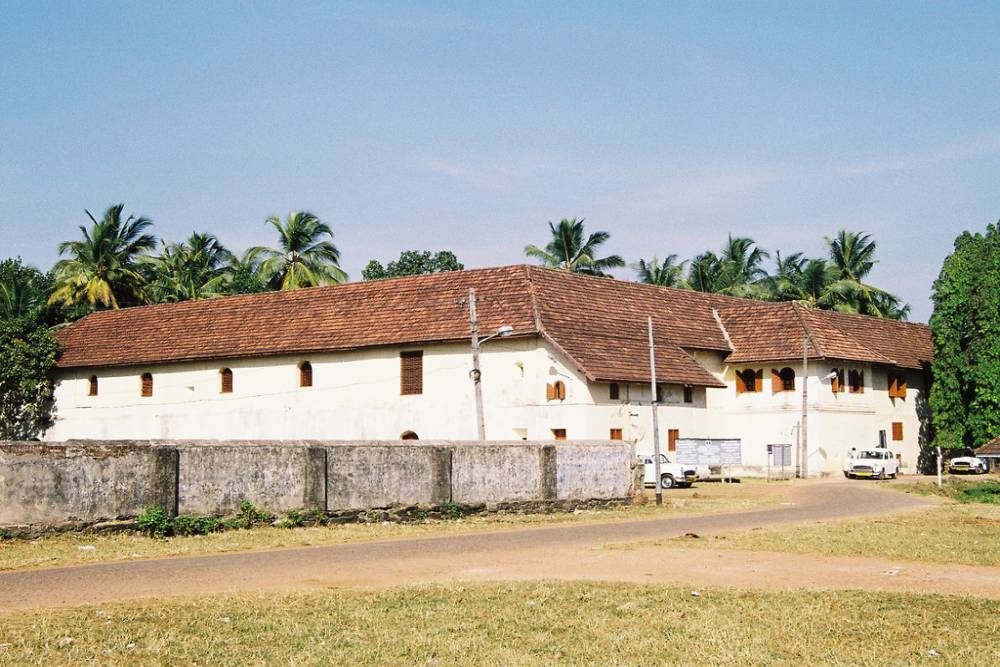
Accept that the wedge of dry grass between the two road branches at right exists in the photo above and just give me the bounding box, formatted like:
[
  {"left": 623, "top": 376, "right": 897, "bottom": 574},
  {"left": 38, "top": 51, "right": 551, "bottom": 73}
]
[{"left": 640, "top": 504, "right": 1000, "bottom": 567}]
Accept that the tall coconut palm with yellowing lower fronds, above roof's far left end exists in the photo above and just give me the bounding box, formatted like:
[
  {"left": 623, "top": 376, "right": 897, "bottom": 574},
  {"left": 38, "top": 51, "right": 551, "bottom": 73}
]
[{"left": 49, "top": 204, "right": 156, "bottom": 309}]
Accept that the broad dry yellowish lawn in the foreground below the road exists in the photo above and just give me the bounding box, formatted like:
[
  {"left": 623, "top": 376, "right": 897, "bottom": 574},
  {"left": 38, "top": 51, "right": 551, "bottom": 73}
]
[{"left": 0, "top": 582, "right": 1000, "bottom": 665}]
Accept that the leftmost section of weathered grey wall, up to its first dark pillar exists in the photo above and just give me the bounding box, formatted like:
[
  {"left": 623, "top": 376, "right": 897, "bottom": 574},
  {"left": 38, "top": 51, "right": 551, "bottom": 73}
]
[{"left": 0, "top": 442, "right": 177, "bottom": 525}]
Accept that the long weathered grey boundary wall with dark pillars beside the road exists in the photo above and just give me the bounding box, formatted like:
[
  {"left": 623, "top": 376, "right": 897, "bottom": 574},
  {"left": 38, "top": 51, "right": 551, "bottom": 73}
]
[{"left": 0, "top": 440, "right": 632, "bottom": 526}]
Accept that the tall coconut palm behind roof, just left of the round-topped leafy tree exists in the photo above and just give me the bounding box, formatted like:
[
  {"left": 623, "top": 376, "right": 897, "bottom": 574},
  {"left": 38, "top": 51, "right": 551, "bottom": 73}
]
[{"left": 246, "top": 211, "right": 347, "bottom": 290}]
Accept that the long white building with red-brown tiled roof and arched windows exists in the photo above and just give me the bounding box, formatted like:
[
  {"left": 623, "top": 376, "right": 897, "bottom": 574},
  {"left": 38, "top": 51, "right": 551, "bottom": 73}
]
[{"left": 45, "top": 266, "right": 931, "bottom": 475}]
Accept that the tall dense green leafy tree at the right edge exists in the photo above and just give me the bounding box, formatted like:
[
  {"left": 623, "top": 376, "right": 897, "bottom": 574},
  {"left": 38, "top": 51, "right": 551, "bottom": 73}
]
[{"left": 930, "top": 223, "right": 1000, "bottom": 449}]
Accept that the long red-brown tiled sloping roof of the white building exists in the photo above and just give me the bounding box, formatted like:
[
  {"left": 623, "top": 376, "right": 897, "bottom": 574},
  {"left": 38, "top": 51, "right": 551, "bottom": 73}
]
[{"left": 58, "top": 266, "right": 930, "bottom": 386}]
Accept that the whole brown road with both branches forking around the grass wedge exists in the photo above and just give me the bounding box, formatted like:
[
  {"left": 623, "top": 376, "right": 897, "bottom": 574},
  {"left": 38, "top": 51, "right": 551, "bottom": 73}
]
[{"left": 0, "top": 482, "right": 1000, "bottom": 611}]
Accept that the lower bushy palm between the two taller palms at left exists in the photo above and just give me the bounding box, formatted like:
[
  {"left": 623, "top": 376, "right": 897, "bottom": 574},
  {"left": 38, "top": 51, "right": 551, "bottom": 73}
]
[{"left": 150, "top": 232, "right": 234, "bottom": 302}]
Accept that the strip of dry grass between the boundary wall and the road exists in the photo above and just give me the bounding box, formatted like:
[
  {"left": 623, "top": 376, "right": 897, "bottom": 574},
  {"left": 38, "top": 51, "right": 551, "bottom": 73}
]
[{"left": 0, "top": 483, "right": 790, "bottom": 570}]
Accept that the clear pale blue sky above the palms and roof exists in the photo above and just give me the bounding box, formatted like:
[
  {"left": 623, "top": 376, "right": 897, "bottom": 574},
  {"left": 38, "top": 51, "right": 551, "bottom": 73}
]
[{"left": 0, "top": 0, "right": 1000, "bottom": 321}]
